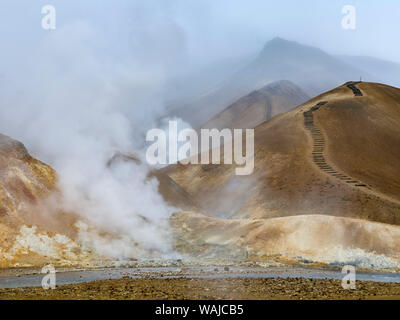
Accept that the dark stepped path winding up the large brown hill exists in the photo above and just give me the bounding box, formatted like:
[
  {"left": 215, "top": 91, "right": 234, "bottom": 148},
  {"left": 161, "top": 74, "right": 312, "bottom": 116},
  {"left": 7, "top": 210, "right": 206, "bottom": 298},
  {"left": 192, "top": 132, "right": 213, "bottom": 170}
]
[{"left": 303, "top": 82, "right": 368, "bottom": 188}]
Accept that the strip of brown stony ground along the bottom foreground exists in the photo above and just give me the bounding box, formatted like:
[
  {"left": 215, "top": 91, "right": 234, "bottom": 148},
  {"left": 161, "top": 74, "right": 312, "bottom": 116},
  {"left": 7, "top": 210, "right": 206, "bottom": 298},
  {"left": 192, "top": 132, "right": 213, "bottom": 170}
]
[{"left": 0, "top": 278, "right": 400, "bottom": 300}]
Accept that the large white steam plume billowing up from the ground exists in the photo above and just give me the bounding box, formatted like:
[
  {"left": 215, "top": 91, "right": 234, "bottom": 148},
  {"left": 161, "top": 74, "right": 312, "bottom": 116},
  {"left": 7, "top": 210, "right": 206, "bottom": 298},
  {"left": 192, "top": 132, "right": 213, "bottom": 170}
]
[{"left": 0, "top": 9, "right": 187, "bottom": 258}]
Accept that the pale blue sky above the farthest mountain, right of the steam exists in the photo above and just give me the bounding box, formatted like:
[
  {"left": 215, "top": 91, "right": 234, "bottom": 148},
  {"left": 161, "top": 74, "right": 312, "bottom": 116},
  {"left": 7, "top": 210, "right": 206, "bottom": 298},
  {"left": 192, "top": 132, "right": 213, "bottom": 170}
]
[{"left": 168, "top": 0, "right": 400, "bottom": 62}]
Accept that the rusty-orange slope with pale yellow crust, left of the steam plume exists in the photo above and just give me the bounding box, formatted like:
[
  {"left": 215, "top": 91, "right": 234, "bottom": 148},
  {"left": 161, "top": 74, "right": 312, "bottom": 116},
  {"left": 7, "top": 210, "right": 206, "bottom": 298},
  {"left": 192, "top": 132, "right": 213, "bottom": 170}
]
[{"left": 0, "top": 134, "right": 86, "bottom": 268}]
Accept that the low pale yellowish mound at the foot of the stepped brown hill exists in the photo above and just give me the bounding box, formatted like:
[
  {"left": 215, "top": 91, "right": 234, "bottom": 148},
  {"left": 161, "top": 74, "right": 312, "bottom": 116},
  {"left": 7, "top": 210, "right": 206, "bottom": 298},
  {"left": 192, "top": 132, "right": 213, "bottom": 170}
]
[{"left": 172, "top": 212, "right": 400, "bottom": 270}]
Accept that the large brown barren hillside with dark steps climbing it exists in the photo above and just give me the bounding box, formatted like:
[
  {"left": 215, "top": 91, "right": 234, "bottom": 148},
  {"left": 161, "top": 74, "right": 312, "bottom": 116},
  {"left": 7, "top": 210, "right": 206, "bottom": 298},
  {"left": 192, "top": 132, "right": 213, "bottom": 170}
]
[{"left": 162, "top": 83, "right": 400, "bottom": 224}]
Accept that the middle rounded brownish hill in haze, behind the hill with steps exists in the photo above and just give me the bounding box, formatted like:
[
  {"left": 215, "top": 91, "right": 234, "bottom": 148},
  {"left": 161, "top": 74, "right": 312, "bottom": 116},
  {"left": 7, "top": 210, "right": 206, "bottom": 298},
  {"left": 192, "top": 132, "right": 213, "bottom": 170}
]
[{"left": 201, "top": 80, "right": 310, "bottom": 129}]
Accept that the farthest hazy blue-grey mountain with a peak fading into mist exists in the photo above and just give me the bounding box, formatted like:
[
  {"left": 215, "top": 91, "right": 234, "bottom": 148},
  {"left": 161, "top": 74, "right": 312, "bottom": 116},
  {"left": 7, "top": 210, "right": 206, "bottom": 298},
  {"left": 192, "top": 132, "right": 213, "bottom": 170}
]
[{"left": 171, "top": 38, "right": 371, "bottom": 128}]
